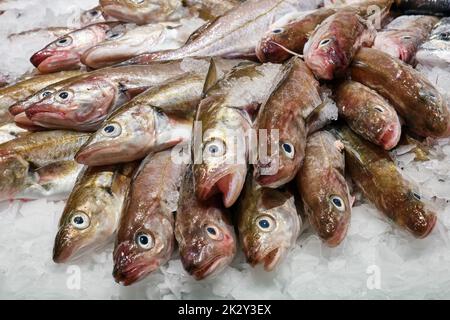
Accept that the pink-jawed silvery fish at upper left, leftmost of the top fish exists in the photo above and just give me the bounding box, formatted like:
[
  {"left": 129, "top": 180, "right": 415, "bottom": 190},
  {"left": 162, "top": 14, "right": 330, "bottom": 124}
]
[{"left": 30, "top": 22, "right": 125, "bottom": 73}]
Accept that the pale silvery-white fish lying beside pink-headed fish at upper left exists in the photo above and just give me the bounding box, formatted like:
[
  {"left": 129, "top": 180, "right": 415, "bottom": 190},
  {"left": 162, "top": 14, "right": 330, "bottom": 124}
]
[{"left": 81, "top": 19, "right": 201, "bottom": 69}]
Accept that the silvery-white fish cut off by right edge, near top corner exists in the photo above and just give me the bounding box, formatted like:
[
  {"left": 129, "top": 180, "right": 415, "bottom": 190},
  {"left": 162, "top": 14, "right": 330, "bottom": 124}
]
[{"left": 416, "top": 18, "right": 450, "bottom": 68}]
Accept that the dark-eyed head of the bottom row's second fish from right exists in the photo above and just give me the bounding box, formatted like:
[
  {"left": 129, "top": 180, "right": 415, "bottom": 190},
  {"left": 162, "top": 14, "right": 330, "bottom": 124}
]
[{"left": 305, "top": 168, "right": 352, "bottom": 247}]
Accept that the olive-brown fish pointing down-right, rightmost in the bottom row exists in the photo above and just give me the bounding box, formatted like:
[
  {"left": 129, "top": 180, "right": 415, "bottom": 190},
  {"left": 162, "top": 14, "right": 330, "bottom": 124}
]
[{"left": 336, "top": 127, "right": 436, "bottom": 238}]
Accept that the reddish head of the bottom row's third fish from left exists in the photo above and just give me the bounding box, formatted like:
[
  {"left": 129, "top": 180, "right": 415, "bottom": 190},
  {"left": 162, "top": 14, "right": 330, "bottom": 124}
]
[{"left": 177, "top": 205, "right": 236, "bottom": 280}]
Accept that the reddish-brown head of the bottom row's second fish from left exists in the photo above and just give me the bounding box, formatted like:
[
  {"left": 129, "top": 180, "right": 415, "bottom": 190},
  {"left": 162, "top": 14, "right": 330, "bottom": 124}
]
[{"left": 113, "top": 214, "right": 175, "bottom": 286}]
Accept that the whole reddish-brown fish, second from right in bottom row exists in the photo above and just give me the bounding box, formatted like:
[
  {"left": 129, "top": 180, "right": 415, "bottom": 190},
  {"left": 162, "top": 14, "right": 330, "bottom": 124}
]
[{"left": 297, "top": 131, "right": 352, "bottom": 247}]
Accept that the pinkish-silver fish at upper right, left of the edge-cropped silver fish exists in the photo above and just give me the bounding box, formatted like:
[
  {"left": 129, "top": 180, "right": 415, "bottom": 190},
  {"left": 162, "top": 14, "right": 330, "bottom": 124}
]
[{"left": 373, "top": 15, "right": 439, "bottom": 64}]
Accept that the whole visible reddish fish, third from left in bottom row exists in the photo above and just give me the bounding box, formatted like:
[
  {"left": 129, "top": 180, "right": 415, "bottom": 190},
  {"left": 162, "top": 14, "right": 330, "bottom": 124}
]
[{"left": 175, "top": 167, "right": 236, "bottom": 280}]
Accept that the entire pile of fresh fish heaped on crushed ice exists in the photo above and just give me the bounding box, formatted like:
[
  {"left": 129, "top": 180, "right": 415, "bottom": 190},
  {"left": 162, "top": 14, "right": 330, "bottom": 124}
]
[{"left": 0, "top": 0, "right": 450, "bottom": 285}]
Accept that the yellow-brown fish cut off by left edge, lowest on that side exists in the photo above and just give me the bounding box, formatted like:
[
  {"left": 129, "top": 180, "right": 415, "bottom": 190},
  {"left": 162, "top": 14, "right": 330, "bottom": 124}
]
[{"left": 0, "top": 131, "right": 89, "bottom": 200}]
